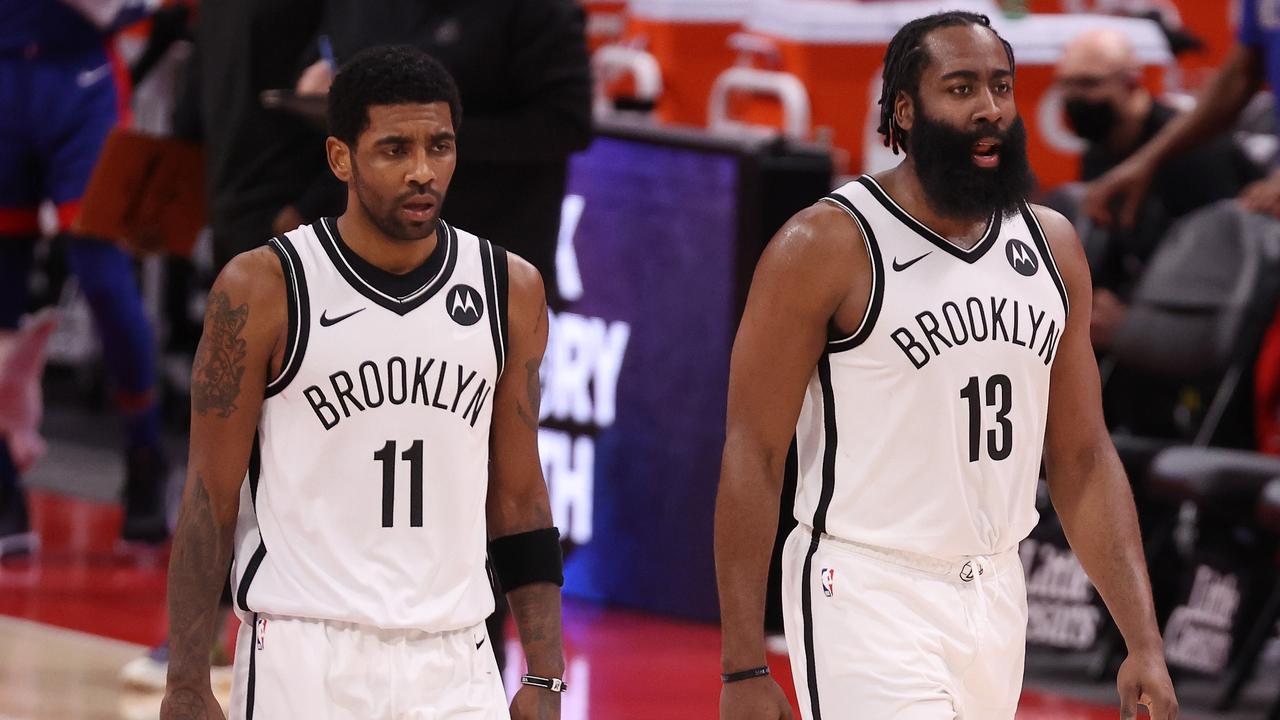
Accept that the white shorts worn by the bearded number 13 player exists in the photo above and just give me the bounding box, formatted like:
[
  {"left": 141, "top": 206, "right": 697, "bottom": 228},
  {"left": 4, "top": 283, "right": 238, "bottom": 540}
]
[{"left": 782, "top": 524, "right": 1027, "bottom": 720}]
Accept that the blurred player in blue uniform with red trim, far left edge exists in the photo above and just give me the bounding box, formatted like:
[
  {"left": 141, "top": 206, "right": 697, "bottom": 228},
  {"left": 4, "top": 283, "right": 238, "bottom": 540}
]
[{"left": 0, "top": 0, "right": 168, "bottom": 553}]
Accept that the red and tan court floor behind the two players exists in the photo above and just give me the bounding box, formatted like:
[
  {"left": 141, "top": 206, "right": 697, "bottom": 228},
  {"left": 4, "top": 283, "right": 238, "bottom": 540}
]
[{"left": 0, "top": 492, "right": 1119, "bottom": 720}]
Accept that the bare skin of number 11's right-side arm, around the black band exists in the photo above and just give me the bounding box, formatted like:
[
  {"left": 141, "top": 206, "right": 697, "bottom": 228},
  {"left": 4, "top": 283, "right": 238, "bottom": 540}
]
[{"left": 488, "top": 255, "right": 564, "bottom": 720}]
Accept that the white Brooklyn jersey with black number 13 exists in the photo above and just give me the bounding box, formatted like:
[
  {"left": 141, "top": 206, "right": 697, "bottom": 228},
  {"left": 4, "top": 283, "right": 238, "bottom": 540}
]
[{"left": 795, "top": 176, "right": 1068, "bottom": 557}]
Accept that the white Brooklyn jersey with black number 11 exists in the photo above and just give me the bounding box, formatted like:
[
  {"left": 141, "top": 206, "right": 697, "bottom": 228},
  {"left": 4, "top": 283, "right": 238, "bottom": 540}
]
[{"left": 233, "top": 219, "right": 507, "bottom": 632}]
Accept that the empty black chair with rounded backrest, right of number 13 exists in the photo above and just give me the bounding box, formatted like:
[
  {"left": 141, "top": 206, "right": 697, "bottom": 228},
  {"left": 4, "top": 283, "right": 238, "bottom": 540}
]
[{"left": 1091, "top": 200, "right": 1280, "bottom": 679}]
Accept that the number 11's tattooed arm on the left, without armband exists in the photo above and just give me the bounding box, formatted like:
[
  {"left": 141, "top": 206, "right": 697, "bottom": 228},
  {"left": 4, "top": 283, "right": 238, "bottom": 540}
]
[{"left": 160, "top": 249, "right": 287, "bottom": 720}]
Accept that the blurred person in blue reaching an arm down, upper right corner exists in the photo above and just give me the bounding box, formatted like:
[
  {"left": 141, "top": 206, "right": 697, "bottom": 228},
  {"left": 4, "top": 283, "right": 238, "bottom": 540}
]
[{"left": 1084, "top": 0, "right": 1280, "bottom": 228}]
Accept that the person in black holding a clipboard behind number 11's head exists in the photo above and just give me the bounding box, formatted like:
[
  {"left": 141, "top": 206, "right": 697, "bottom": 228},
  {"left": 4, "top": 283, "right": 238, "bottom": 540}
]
[{"left": 298, "top": 0, "right": 591, "bottom": 304}]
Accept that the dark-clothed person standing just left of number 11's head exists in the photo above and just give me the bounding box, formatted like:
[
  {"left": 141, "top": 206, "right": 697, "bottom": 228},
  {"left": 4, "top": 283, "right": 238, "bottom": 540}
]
[{"left": 179, "top": 0, "right": 346, "bottom": 269}]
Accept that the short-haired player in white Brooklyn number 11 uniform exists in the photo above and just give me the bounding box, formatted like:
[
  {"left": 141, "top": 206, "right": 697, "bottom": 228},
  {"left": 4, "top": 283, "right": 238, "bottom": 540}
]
[{"left": 160, "top": 47, "right": 564, "bottom": 720}]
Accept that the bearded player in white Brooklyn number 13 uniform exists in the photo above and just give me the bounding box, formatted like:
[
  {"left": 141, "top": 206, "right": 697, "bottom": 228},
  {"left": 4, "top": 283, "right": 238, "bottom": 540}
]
[{"left": 716, "top": 12, "right": 1178, "bottom": 720}]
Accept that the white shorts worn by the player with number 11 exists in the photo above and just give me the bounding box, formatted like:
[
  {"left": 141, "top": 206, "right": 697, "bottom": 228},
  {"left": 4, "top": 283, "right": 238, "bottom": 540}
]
[{"left": 230, "top": 614, "right": 509, "bottom": 720}]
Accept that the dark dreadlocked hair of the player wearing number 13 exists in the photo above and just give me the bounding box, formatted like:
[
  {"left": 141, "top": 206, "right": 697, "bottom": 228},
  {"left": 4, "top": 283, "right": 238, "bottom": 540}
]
[{"left": 877, "top": 10, "right": 1014, "bottom": 155}]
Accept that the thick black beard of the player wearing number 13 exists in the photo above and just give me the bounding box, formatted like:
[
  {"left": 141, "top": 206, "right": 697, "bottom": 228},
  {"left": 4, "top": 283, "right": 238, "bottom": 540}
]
[{"left": 908, "top": 102, "right": 1036, "bottom": 220}]
